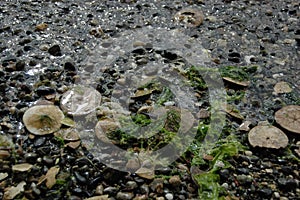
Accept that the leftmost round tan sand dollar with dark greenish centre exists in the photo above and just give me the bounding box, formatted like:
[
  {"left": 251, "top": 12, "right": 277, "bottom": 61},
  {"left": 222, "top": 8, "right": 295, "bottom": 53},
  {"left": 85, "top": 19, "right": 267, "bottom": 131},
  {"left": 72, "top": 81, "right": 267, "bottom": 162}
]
[{"left": 23, "top": 105, "right": 65, "bottom": 135}]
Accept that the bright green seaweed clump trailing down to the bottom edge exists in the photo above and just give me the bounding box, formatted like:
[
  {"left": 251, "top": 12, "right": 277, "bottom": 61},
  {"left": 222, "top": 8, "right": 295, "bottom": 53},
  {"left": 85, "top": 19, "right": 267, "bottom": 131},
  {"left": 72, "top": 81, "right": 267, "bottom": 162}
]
[{"left": 189, "top": 119, "right": 245, "bottom": 200}]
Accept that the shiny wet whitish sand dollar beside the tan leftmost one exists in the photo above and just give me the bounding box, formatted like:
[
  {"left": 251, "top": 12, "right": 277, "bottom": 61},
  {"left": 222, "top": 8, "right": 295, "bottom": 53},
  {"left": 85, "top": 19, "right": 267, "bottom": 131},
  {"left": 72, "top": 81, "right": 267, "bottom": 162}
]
[{"left": 60, "top": 85, "right": 101, "bottom": 116}]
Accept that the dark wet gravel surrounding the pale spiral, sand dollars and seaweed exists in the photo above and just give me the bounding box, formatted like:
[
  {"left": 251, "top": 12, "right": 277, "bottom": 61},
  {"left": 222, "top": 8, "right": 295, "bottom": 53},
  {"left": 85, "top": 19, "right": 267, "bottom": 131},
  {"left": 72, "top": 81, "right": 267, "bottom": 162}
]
[{"left": 0, "top": 0, "right": 300, "bottom": 200}]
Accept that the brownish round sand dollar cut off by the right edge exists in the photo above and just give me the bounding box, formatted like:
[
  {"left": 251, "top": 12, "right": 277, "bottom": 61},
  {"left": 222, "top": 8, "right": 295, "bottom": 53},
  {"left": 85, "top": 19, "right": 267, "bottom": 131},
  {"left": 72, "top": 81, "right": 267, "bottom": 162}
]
[{"left": 275, "top": 105, "right": 300, "bottom": 133}]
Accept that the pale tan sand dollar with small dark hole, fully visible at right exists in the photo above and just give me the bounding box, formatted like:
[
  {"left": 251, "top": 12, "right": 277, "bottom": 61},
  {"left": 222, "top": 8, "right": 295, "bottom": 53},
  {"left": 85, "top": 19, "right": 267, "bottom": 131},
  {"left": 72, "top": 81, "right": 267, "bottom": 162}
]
[{"left": 248, "top": 125, "right": 289, "bottom": 149}]
